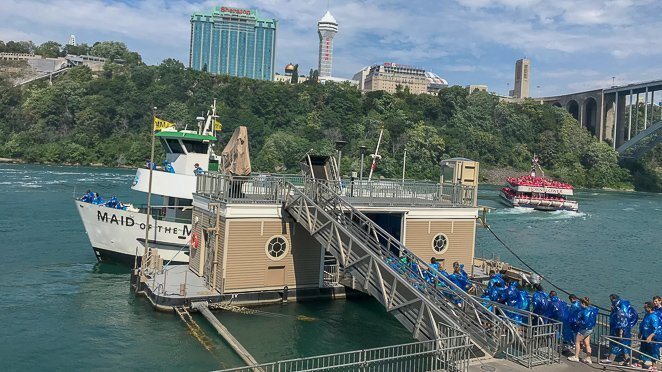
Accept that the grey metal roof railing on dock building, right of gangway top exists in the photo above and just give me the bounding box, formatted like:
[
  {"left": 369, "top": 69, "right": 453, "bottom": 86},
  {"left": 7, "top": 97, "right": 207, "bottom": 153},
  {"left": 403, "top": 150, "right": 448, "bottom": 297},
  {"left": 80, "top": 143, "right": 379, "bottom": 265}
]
[{"left": 340, "top": 179, "right": 477, "bottom": 207}]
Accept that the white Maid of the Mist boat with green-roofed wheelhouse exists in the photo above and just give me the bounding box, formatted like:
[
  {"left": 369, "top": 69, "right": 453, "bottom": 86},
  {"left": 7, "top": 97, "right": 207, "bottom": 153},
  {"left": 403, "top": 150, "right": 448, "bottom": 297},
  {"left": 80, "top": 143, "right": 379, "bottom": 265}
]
[{"left": 75, "top": 105, "right": 218, "bottom": 265}]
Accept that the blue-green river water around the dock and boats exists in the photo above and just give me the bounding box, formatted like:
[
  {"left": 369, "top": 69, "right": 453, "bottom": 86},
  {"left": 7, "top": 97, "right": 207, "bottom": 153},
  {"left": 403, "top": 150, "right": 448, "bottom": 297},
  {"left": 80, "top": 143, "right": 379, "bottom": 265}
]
[{"left": 0, "top": 164, "right": 662, "bottom": 370}]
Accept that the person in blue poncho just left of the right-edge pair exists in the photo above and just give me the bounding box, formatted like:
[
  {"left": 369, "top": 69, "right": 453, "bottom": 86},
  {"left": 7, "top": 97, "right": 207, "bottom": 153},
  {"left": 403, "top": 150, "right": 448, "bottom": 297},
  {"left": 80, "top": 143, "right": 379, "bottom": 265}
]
[{"left": 601, "top": 294, "right": 639, "bottom": 364}]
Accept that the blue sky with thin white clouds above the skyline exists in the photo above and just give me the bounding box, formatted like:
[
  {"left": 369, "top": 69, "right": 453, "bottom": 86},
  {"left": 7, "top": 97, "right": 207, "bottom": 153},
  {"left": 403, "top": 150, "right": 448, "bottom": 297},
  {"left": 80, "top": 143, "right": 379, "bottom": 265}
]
[{"left": 0, "top": 0, "right": 662, "bottom": 96}]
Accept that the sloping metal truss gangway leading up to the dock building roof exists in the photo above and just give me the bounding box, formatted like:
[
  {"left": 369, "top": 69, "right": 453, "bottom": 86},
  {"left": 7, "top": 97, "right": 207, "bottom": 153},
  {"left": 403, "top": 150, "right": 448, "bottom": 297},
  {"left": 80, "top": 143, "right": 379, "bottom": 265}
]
[{"left": 284, "top": 181, "right": 521, "bottom": 355}]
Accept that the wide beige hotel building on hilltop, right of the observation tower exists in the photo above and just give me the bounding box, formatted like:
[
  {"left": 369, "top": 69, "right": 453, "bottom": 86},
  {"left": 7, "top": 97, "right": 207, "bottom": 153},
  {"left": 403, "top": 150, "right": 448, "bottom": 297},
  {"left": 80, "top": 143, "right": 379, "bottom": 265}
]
[{"left": 354, "top": 62, "right": 448, "bottom": 94}]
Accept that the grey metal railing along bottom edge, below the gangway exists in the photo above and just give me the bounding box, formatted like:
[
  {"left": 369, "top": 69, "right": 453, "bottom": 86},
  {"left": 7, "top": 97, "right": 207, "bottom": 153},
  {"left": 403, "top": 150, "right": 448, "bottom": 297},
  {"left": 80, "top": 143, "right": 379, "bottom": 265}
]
[{"left": 218, "top": 334, "right": 471, "bottom": 372}]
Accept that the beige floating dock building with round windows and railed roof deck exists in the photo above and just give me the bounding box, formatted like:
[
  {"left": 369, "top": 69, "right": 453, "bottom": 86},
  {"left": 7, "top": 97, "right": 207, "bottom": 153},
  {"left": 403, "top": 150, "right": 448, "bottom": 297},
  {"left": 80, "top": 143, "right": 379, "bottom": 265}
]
[{"left": 189, "top": 155, "right": 478, "bottom": 302}]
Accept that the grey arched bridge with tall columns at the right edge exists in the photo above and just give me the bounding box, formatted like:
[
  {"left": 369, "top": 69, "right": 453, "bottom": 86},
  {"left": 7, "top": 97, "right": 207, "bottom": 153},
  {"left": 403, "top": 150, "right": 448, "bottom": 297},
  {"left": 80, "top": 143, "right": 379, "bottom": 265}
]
[{"left": 540, "top": 80, "right": 662, "bottom": 156}]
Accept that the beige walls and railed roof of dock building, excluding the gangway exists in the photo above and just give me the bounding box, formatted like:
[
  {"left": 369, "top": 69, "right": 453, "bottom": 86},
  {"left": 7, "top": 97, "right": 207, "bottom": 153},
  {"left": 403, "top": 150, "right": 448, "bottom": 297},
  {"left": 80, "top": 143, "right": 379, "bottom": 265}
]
[{"left": 189, "top": 158, "right": 478, "bottom": 294}]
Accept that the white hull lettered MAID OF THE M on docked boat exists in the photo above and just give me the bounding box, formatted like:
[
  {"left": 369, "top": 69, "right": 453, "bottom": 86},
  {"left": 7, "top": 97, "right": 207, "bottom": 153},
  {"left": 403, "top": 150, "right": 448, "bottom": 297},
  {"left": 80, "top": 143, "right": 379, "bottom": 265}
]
[{"left": 75, "top": 200, "right": 191, "bottom": 265}]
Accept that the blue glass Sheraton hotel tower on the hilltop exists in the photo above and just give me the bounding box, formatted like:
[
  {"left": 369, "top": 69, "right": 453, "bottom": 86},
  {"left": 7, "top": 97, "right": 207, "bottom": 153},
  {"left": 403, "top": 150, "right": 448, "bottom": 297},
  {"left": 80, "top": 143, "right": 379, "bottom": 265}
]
[{"left": 189, "top": 6, "right": 277, "bottom": 80}]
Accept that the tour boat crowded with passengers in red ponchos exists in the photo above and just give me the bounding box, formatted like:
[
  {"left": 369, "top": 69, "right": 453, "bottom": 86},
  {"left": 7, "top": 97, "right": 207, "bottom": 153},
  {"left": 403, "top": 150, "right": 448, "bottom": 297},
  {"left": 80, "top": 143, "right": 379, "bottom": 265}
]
[{"left": 499, "top": 156, "right": 579, "bottom": 212}]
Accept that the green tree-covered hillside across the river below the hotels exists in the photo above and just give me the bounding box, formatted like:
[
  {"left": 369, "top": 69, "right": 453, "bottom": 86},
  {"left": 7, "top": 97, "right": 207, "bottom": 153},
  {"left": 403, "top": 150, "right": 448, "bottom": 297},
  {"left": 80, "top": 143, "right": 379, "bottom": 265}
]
[{"left": 0, "top": 40, "right": 660, "bottom": 188}]
